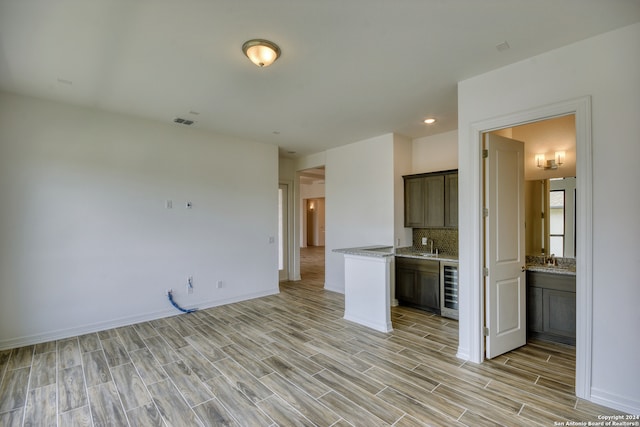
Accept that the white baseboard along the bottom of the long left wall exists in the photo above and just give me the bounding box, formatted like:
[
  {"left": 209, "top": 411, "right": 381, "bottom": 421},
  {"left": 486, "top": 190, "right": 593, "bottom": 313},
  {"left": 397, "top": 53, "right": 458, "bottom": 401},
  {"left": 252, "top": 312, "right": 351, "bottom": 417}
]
[{"left": 0, "top": 288, "right": 280, "bottom": 351}]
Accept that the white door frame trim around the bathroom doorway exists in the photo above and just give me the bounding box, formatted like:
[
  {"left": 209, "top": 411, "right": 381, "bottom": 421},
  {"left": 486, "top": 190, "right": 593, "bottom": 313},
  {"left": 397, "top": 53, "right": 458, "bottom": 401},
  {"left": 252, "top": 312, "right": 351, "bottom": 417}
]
[{"left": 468, "top": 96, "right": 593, "bottom": 400}]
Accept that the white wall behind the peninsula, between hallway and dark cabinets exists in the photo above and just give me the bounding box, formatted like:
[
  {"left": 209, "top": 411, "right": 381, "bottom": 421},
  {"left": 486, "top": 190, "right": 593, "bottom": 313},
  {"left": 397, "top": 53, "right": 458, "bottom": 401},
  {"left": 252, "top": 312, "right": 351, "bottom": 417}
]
[{"left": 325, "top": 134, "right": 395, "bottom": 293}]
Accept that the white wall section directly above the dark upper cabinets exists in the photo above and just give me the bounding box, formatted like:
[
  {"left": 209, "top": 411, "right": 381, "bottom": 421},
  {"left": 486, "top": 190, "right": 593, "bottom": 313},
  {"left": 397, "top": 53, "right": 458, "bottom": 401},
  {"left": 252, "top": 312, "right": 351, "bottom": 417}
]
[{"left": 411, "top": 130, "right": 458, "bottom": 173}]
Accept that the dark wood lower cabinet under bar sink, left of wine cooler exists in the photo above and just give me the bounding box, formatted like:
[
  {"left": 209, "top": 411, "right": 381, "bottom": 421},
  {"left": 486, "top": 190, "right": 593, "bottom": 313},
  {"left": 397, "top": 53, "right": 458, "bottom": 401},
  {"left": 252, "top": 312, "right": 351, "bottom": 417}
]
[{"left": 395, "top": 257, "right": 440, "bottom": 314}]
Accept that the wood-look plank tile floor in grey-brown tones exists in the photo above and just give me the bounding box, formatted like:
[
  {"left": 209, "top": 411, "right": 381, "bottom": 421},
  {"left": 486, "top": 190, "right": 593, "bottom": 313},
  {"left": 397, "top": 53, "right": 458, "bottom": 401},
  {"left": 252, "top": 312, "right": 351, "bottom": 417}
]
[{"left": 0, "top": 249, "right": 619, "bottom": 427}]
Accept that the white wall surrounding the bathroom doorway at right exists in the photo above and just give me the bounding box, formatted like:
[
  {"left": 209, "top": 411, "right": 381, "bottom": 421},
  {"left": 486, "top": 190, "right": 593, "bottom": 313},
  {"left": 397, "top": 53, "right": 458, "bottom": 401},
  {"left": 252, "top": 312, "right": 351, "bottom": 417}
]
[{"left": 458, "top": 24, "right": 640, "bottom": 414}]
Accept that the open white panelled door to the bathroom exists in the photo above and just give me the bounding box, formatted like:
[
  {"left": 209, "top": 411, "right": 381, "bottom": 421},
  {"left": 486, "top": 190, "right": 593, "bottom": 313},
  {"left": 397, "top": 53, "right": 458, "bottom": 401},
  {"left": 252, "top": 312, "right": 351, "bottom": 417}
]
[{"left": 484, "top": 134, "right": 527, "bottom": 359}]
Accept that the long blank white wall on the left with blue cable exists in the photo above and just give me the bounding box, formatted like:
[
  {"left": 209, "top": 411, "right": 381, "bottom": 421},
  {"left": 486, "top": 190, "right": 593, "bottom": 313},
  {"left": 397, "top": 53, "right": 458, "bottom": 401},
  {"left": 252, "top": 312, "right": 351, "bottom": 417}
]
[{"left": 0, "top": 94, "right": 278, "bottom": 348}]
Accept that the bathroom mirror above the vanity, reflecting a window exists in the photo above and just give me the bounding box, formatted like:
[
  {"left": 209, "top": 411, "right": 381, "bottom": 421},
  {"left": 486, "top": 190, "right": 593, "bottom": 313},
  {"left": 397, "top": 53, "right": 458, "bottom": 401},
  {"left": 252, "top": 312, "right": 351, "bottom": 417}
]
[{"left": 525, "top": 177, "right": 576, "bottom": 258}]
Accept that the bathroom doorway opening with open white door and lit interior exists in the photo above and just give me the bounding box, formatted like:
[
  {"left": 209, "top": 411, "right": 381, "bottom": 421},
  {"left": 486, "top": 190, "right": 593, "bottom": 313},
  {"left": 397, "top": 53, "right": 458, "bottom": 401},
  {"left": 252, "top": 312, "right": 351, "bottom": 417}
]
[{"left": 484, "top": 114, "right": 576, "bottom": 358}]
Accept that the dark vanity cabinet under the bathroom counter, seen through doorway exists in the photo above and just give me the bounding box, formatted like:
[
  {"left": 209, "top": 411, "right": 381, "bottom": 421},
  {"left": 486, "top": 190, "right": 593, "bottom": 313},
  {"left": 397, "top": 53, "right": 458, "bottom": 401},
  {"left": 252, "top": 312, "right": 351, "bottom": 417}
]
[{"left": 527, "top": 271, "right": 576, "bottom": 345}]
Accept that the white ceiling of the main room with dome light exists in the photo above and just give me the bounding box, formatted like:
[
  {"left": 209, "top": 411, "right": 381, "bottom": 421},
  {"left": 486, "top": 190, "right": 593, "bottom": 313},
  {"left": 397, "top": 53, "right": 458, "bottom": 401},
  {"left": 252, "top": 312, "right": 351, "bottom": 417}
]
[{"left": 0, "top": 0, "right": 640, "bottom": 157}]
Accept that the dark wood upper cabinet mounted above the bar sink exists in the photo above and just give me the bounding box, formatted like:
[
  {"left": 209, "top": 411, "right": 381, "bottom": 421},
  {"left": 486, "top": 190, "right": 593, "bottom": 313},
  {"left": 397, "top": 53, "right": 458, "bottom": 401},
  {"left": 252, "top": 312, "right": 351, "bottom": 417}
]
[{"left": 403, "top": 170, "right": 458, "bottom": 228}]
